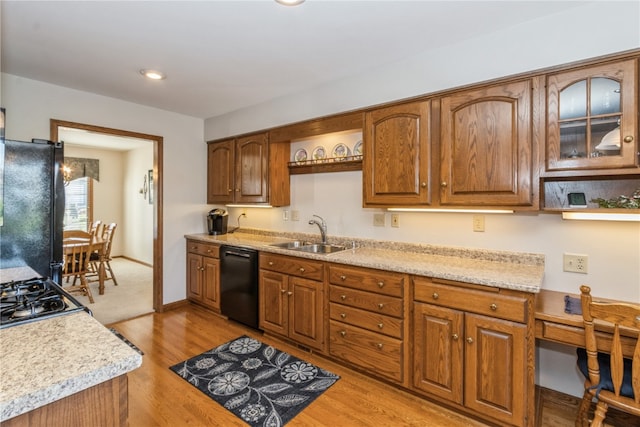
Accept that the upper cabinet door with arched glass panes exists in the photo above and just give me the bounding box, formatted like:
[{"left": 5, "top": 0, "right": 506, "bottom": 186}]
[{"left": 546, "top": 59, "right": 638, "bottom": 171}]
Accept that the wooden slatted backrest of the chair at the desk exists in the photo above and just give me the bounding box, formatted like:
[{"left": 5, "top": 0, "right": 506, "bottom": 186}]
[{"left": 580, "top": 286, "right": 640, "bottom": 404}]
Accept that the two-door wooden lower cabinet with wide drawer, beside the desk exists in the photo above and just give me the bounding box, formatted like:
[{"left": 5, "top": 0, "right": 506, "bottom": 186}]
[{"left": 413, "top": 278, "right": 535, "bottom": 426}]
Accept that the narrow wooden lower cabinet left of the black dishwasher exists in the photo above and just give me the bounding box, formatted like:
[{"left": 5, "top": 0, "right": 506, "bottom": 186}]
[{"left": 187, "top": 240, "right": 220, "bottom": 312}]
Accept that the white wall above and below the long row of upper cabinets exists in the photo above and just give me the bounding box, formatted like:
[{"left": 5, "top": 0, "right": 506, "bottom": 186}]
[{"left": 200, "top": 1, "right": 640, "bottom": 396}]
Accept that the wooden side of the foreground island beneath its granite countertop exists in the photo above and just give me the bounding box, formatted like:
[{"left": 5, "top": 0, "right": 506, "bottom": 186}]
[{"left": 2, "top": 374, "right": 129, "bottom": 427}]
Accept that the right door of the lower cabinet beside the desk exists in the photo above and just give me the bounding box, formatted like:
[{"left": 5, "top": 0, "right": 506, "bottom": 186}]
[{"left": 464, "top": 313, "right": 530, "bottom": 425}]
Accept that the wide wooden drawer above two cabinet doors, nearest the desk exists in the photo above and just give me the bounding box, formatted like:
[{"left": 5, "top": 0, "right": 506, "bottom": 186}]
[{"left": 414, "top": 278, "right": 527, "bottom": 323}]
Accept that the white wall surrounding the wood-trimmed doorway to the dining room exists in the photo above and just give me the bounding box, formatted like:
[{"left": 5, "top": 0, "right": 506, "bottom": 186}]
[{"left": 2, "top": 73, "right": 207, "bottom": 304}]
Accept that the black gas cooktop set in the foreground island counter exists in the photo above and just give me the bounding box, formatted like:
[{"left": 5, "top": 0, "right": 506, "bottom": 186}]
[{"left": 0, "top": 277, "right": 91, "bottom": 328}]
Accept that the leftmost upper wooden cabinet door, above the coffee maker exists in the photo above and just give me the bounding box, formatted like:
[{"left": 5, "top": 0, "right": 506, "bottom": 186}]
[{"left": 207, "top": 140, "right": 235, "bottom": 203}]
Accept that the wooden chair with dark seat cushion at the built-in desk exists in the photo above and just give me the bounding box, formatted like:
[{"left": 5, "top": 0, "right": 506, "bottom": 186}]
[{"left": 576, "top": 286, "right": 640, "bottom": 427}]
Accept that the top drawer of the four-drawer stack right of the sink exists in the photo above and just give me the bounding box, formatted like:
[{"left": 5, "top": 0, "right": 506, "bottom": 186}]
[{"left": 329, "top": 265, "right": 404, "bottom": 297}]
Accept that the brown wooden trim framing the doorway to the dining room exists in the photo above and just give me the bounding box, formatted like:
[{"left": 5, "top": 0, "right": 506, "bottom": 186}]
[{"left": 50, "top": 119, "right": 164, "bottom": 312}]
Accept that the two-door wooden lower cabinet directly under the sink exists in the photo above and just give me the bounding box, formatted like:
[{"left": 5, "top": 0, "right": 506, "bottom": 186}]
[{"left": 259, "top": 254, "right": 325, "bottom": 351}]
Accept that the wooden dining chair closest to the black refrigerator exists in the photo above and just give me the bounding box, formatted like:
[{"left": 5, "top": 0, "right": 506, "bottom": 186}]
[{"left": 62, "top": 230, "right": 94, "bottom": 303}]
